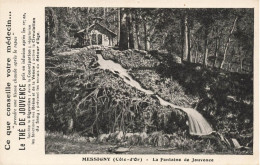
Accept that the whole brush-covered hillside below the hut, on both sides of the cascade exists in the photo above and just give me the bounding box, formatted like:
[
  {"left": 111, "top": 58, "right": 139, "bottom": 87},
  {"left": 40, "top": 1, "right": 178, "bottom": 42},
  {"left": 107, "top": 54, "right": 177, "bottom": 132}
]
[{"left": 45, "top": 47, "right": 253, "bottom": 154}]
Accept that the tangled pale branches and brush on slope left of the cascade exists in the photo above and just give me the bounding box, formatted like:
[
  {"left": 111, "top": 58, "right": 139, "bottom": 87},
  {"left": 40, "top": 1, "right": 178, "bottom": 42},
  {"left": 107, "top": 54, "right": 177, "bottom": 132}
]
[{"left": 46, "top": 49, "right": 188, "bottom": 135}]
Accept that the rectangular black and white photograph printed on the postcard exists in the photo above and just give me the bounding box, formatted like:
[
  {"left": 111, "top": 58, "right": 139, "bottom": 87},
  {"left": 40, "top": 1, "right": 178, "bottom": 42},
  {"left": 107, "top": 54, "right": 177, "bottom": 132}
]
[{"left": 45, "top": 7, "right": 256, "bottom": 155}]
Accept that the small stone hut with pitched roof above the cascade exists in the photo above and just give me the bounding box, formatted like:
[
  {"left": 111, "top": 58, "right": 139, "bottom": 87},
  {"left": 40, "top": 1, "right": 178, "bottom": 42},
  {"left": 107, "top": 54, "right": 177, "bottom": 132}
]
[{"left": 75, "top": 22, "right": 116, "bottom": 47}]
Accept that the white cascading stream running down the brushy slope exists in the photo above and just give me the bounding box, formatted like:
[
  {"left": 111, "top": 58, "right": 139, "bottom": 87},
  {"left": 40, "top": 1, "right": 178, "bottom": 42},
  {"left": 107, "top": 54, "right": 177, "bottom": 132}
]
[{"left": 97, "top": 54, "right": 214, "bottom": 136}]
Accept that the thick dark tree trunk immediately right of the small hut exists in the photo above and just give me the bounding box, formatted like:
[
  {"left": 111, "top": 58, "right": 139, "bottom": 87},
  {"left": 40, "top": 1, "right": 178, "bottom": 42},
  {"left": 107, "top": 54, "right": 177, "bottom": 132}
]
[{"left": 119, "top": 9, "right": 128, "bottom": 50}]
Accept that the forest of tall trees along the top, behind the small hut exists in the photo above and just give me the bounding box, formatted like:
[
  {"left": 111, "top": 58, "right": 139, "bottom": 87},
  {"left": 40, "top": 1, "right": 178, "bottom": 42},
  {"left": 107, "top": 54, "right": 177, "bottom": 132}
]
[{"left": 45, "top": 8, "right": 254, "bottom": 73}]
